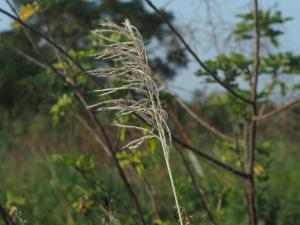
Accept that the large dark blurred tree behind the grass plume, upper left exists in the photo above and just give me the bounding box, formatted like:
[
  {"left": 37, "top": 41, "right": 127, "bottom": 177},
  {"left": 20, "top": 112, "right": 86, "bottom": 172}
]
[{"left": 1, "top": 0, "right": 187, "bottom": 112}]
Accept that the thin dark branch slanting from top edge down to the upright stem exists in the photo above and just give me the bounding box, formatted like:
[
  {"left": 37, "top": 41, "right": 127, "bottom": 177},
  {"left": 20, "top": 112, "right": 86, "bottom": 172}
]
[{"left": 145, "top": 0, "right": 252, "bottom": 104}]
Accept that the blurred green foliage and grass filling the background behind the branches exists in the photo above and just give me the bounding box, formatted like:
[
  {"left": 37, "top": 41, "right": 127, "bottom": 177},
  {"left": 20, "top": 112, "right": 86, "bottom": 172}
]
[{"left": 0, "top": 0, "right": 300, "bottom": 225}]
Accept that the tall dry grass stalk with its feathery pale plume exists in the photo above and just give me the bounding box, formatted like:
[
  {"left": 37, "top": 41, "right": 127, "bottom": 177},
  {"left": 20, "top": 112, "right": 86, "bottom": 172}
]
[{"left": 90, "top": 20, "right": 183, "bottom": 225}]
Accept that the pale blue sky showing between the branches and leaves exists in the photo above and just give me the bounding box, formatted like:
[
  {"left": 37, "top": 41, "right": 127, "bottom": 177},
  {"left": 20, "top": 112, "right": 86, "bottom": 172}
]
[{"left": 0, "top": 0, "right": 300, "bottom": 99}]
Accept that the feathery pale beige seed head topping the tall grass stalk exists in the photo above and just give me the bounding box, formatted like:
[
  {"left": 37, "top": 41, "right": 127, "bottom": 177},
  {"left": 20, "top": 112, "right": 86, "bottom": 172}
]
[{"left": 90, "top": 20, "right": 171, "bottom": 155}]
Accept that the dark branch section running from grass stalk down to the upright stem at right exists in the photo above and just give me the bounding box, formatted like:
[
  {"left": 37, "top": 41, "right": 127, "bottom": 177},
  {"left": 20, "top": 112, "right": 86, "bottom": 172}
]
[{"left": 172, "top": 135, "right": 250, "bottom": 179}]
